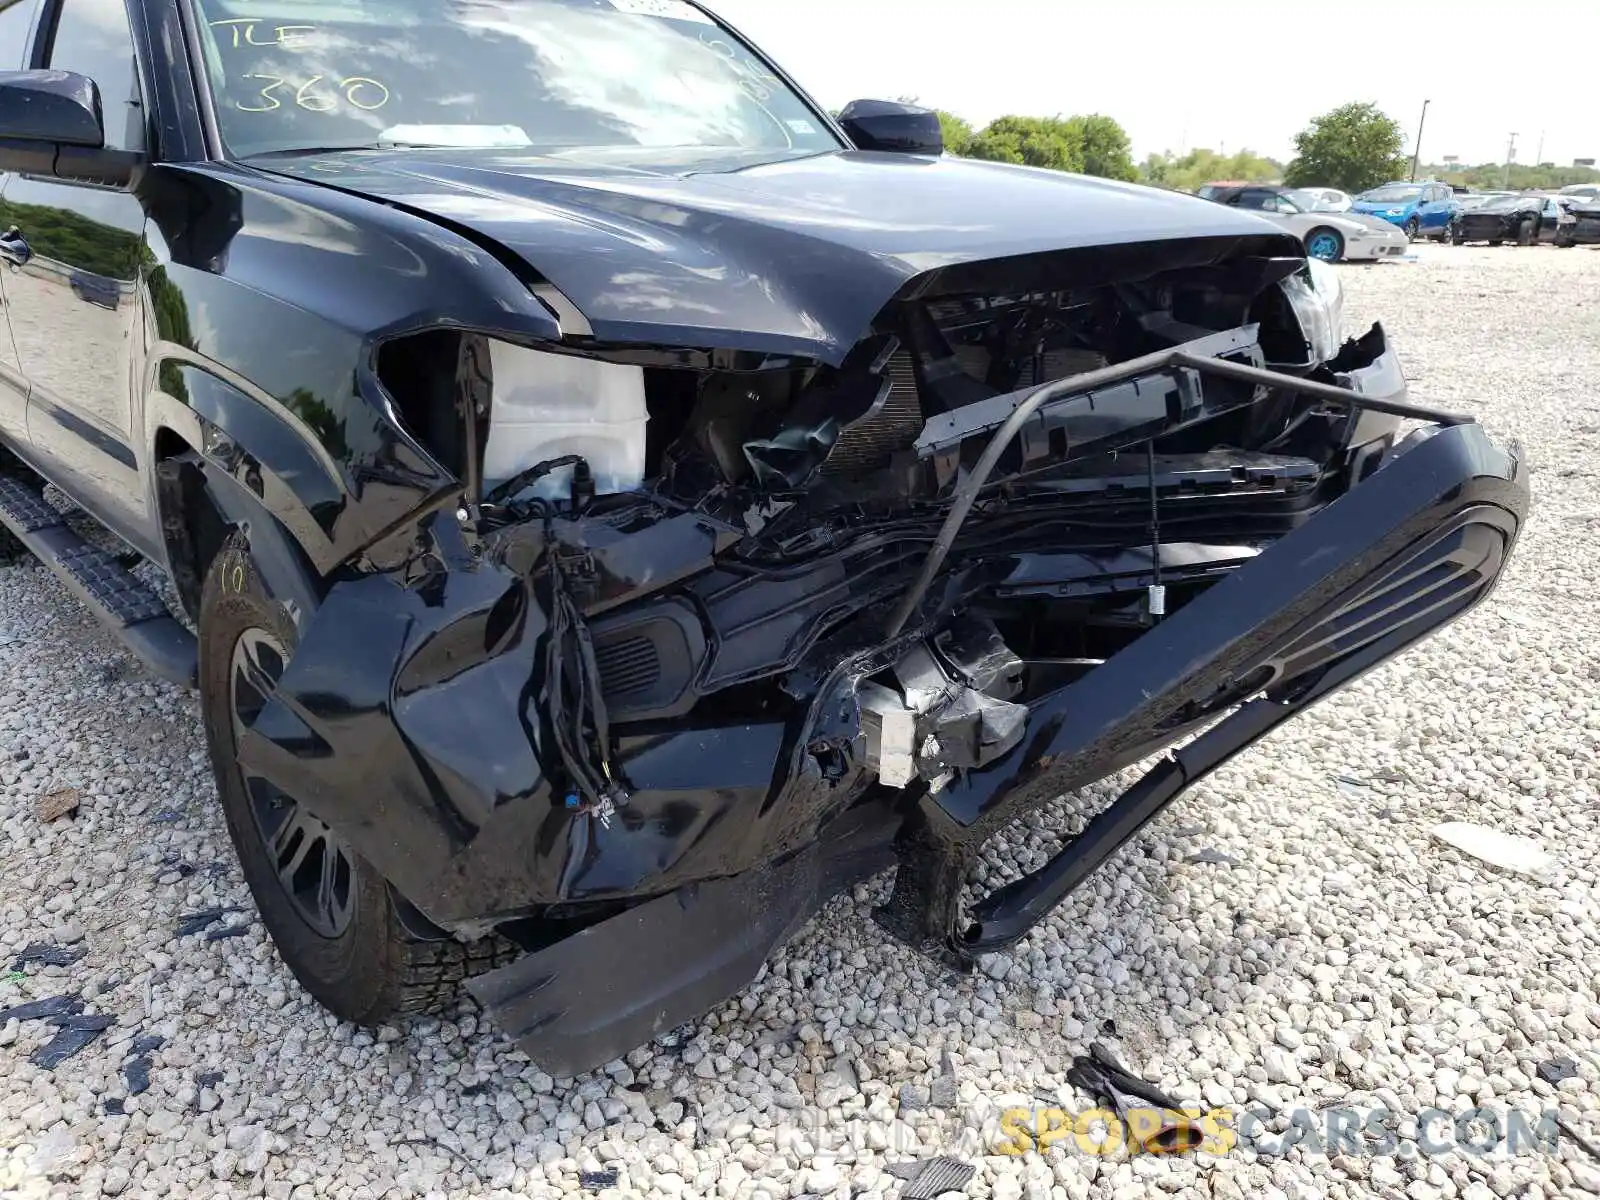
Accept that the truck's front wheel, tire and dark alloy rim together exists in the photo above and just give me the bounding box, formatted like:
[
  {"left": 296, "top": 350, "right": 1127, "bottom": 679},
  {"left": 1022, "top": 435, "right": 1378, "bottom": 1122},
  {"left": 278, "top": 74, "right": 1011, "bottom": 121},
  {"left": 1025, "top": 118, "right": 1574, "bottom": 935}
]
[{"left": 200, "top": 534, "right": 509, "bottom": 1026}]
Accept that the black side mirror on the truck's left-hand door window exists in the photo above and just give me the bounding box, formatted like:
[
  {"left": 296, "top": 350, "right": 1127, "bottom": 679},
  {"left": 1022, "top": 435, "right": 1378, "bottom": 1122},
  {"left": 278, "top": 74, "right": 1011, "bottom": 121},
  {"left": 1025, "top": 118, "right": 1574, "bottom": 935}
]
[{"left": 0, "top": 70, "right": 139, "bottom": 184}]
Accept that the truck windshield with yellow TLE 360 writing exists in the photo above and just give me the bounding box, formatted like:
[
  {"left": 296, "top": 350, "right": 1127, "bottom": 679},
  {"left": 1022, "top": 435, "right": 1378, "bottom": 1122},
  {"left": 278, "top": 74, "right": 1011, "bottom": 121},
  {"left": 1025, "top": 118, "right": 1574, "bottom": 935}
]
[{"left": 188, "top": 0, "right": 842, "bottom": 158}]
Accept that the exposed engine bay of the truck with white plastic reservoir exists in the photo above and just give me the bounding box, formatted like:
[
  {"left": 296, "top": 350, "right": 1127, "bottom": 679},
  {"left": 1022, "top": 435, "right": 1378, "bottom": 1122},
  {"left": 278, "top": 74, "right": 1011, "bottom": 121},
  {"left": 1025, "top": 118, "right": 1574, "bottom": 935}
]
[{"left": 393, "top": 258, "right": 1394, "bottom": 811}]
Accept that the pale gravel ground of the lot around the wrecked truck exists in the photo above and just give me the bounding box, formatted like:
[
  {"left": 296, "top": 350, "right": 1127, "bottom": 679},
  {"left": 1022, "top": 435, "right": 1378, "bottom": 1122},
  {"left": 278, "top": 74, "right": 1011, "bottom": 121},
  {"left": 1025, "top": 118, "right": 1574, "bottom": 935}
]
[{"left": 0, "top": 246, "right": 1600, "bottom": 1200}]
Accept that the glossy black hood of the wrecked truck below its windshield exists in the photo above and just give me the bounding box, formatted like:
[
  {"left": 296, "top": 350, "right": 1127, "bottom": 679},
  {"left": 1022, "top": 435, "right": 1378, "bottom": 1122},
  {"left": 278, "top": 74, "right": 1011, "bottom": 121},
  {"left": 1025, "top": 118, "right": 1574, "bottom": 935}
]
[{"left": 256, "top": 147, "right": 1283, "bottom": 365}]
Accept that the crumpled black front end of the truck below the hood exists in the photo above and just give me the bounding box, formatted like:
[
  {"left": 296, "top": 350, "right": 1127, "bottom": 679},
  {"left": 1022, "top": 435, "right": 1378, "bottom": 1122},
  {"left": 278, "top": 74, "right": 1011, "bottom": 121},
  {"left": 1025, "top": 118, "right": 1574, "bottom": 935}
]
[{"left": 232, "top": 240, "right": 1526, "bottom": 1072}]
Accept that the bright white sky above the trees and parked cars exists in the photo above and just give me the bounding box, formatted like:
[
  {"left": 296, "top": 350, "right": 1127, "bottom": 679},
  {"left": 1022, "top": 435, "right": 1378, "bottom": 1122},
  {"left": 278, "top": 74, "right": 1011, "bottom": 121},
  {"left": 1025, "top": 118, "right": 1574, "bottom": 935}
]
[{"left": 707, "top": 0, "right": 1600, "bottom": 165}]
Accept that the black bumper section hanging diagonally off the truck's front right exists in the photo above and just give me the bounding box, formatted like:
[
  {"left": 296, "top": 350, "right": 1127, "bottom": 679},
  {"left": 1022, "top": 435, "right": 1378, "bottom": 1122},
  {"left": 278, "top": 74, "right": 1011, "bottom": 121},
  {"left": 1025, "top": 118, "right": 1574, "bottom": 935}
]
[{"left": 877, "top": 424, "right": 1528, "bottom": 966}]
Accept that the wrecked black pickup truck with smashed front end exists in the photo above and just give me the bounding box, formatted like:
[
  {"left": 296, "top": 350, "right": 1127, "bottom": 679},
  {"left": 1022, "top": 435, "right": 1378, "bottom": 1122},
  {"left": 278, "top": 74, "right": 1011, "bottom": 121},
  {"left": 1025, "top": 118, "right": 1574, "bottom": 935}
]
[{"left": 0, "top": 0, "right": 1528, "bottom": 1072}]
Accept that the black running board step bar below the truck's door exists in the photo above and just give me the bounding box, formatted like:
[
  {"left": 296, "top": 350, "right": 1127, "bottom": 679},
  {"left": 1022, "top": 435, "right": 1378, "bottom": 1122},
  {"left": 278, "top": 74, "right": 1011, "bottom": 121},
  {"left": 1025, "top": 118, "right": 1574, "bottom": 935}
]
[{"left": 0, "top": 475, "right": 198, "bottom": 688}]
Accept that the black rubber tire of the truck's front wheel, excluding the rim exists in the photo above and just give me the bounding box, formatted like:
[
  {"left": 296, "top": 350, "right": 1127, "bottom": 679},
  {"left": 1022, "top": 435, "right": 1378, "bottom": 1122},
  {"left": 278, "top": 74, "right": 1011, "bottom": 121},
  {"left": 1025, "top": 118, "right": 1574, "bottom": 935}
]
[{"left": 200, "top": 533, "right": 520, "bottom": 1026}]
